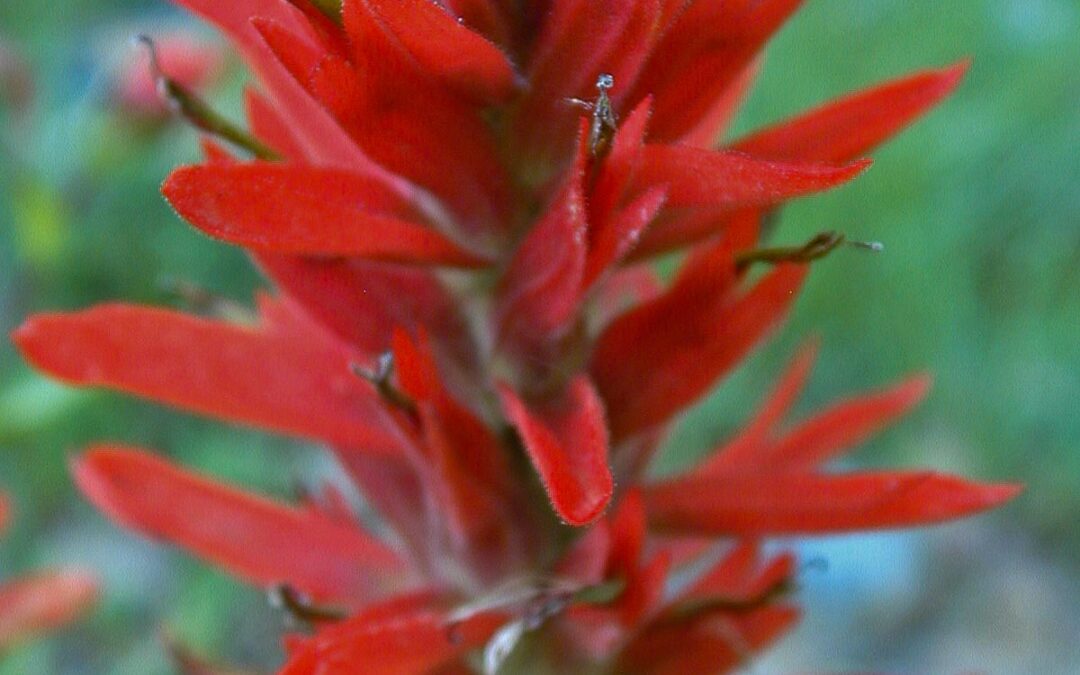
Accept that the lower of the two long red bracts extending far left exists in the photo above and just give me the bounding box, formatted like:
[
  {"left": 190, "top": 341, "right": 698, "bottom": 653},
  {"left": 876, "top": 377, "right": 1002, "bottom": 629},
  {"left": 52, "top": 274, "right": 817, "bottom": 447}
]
[{"left": 72, "top": 446, "right": 402, "bottom": 602}]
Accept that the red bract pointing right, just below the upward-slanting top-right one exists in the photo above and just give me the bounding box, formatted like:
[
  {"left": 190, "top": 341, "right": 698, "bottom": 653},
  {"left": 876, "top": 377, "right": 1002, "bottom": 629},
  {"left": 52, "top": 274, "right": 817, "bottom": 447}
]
[{"left": 635, "top": 145, "right": 870, "bottom": 211}]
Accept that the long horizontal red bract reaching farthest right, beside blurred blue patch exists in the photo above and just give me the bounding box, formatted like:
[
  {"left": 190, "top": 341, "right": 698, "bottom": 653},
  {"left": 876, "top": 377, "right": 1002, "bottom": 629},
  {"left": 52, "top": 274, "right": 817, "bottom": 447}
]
[{"left": 645, "top": 472, "right": 1021, "bottom": 537}]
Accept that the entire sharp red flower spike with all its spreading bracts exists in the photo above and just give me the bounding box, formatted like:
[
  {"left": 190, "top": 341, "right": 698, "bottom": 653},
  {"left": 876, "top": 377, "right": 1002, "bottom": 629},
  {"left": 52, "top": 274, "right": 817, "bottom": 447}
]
[{"left": 15, "top": 0, "right": 1017, "bottom": 675}]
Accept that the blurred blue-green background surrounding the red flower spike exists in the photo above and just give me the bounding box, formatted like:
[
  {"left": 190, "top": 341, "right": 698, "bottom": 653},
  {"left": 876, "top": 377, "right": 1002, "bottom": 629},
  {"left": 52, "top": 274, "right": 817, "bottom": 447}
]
[{"left": 0, "top": 0, "right": 1080, "bottom": 674}]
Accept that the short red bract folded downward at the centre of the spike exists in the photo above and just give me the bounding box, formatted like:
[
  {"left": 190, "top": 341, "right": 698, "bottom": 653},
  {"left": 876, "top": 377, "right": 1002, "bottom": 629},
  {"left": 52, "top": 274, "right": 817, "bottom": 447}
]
[{"left": 499, "top": 376, "right": 615, "bottom": 525}]
